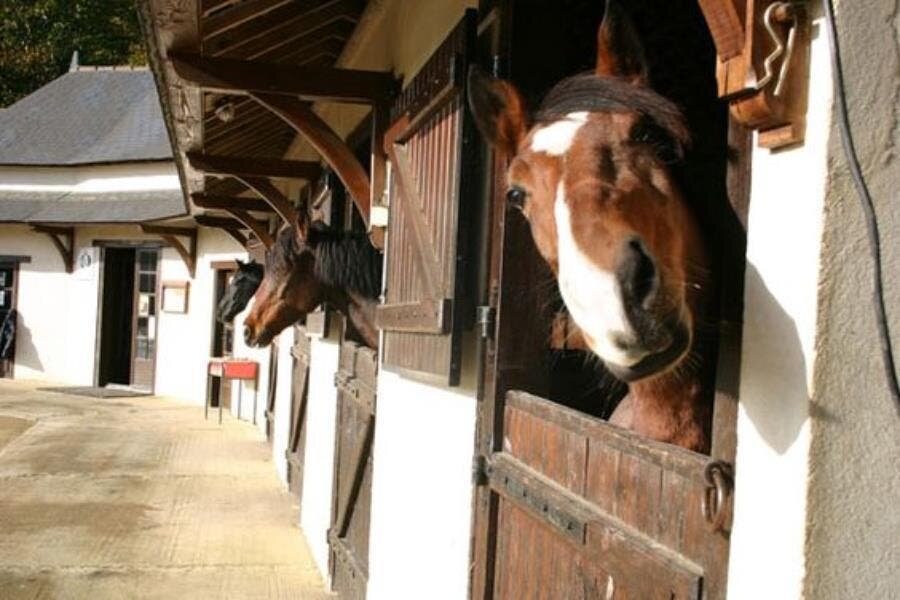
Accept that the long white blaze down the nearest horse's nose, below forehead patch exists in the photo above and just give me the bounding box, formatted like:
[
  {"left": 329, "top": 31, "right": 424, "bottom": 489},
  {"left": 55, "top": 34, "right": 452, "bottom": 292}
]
[{"left": 553, "top": 182, "right": 646, "bottom": 367}]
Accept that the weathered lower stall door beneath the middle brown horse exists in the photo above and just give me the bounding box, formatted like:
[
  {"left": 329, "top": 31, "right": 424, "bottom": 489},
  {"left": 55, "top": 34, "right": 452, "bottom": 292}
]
[{"left": 328, "top": 341, "right": 378, "bottom": 600}]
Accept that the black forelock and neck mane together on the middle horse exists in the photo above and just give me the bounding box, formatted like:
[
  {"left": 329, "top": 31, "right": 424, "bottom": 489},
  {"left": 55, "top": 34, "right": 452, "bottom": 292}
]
[{"left": 266, "top": 227, "right": 382, "bottom": 298}]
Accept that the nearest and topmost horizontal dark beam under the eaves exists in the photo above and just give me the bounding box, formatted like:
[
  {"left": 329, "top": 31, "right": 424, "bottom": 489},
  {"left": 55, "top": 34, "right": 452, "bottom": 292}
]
[{"left": 169, "top": 53, "right": 396, "bottom": 104}]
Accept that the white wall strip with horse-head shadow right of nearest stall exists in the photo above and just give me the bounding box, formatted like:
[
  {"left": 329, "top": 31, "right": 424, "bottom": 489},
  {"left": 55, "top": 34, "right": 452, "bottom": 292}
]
[{"left": 728, "top": 11, "right": 831, "bottom": 599}]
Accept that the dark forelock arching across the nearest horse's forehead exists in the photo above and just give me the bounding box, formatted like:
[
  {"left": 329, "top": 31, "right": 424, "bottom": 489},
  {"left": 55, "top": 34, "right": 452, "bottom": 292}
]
[{"left": 535, "top": 73, "right": 691, "bottom": 155}]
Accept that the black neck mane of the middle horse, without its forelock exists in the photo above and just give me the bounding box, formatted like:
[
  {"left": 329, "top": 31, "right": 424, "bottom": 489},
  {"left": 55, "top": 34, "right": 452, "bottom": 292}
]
[{"left": 314, "top": 232, "right": 383, "bottom": 298}]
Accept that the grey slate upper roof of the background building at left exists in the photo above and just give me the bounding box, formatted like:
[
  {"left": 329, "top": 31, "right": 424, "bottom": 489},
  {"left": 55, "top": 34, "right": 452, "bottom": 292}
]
[{"left": 0, "top": 69, "right": 172, "bottom": 165}]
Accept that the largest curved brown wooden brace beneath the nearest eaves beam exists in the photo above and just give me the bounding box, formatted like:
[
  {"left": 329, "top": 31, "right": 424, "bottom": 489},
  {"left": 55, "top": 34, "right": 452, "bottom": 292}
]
[{"left": 253, "top": 94, "right": 371, "bottom": 227}]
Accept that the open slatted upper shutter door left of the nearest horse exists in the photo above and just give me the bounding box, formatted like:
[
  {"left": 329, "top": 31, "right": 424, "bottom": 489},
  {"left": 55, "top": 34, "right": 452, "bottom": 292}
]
[{"left": 377, "top": 11, "right": 477, "bottom": 385}]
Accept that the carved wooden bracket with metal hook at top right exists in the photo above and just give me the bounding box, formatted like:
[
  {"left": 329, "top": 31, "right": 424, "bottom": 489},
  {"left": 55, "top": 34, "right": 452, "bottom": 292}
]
[{"left": 699, "top": 0, "right": 810, "bottom": 148}]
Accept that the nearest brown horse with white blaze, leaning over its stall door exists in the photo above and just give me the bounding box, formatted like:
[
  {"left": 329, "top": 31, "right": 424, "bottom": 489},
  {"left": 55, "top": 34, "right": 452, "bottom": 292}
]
[{"left": 469, "top": 0, "right": 709, "bottom": 451}]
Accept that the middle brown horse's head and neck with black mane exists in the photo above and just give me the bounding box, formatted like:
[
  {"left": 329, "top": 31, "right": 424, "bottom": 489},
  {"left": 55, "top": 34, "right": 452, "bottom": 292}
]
[{"left": 244, "top": 226, "right": 382, "bottom": 347}]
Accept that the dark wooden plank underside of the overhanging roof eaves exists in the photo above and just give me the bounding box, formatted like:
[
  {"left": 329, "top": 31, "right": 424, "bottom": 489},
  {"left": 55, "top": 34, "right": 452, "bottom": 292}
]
[{"left": 138, "top": 0, "right": 370, "bottom": 241}]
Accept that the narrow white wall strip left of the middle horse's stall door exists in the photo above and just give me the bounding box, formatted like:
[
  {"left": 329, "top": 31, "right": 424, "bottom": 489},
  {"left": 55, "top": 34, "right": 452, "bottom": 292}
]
[{"left": 300, "top": 327, "right": 340, "bottom": 579}]
